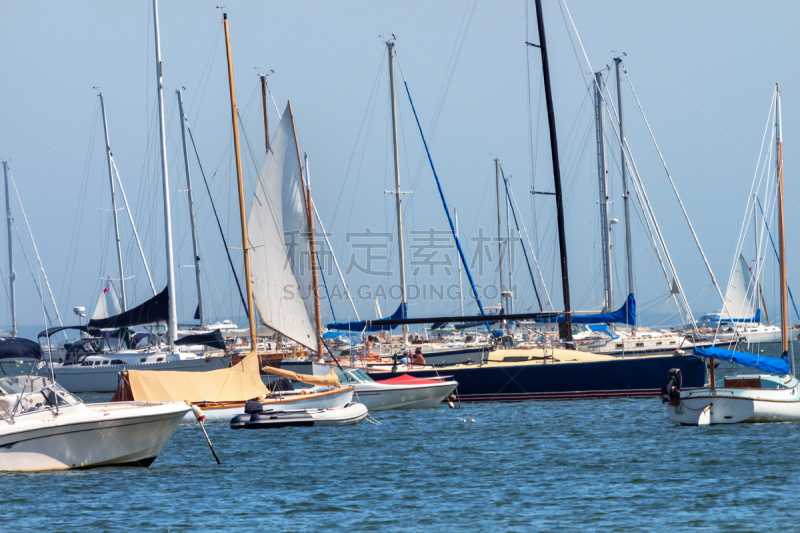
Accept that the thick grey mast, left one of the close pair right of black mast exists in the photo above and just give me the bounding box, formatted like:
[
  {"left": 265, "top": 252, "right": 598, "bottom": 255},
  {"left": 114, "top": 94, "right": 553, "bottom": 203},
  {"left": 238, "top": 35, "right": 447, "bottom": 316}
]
[{"left": 594, "top": 72, "right": 614, "bottom": 312}]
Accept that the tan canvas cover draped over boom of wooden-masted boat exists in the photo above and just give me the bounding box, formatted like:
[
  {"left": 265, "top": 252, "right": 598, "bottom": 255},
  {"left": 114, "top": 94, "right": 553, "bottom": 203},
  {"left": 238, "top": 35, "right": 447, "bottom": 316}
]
[{"left": 111, "top": 354, "right": 269, "bottom": 403}]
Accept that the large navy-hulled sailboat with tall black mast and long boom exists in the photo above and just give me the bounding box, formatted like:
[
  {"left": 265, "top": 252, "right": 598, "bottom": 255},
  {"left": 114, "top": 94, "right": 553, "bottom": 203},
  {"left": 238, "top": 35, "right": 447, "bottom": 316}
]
[{"left": 363, "top": 0, "right": 705, "bottom": 401}]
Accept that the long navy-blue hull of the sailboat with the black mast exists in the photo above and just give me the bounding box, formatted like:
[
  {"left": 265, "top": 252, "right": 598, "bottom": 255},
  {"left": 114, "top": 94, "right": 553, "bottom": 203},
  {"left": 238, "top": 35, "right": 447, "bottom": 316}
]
[{"left": 368, "top": 355, "right": 705, "bottom": 402}]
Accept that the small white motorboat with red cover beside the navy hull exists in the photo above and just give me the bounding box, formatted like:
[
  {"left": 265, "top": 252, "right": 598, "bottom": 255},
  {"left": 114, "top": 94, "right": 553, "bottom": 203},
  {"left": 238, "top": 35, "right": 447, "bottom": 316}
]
[{"left": 339, "top": 369, "right": 458, "bottom": 411}]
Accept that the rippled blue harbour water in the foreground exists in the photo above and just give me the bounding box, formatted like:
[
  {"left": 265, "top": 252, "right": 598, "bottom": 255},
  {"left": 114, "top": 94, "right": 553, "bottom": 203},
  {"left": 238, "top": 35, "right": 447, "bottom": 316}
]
[{"left": 6, "top": 342, "right": 800, "bottom": 531}]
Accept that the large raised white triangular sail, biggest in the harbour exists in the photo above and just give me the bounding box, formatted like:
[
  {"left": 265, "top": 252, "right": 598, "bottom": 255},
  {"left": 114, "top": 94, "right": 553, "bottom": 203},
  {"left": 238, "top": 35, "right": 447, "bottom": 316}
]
[{"left": 247, "top": 106, "right": 317, "bottom": 350}]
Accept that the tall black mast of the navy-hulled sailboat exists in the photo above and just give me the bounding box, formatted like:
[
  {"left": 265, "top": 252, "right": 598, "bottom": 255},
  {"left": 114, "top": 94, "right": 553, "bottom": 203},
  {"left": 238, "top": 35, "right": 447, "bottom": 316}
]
[{"left": 536, "top": 0, "right": 572, "bottom": 347}]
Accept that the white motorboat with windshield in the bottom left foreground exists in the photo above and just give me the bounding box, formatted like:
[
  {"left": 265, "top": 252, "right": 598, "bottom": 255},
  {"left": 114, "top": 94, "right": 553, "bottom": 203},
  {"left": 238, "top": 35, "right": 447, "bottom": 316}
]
[{"left": 0, "top": 376, "right": 191, "bottom": 471}]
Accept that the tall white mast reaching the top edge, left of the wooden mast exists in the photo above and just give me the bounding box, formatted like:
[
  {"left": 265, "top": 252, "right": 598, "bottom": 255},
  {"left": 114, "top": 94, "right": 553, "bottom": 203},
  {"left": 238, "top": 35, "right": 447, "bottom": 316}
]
[{"left": 153, "top": 0, "right": 178, "bottom": 351}]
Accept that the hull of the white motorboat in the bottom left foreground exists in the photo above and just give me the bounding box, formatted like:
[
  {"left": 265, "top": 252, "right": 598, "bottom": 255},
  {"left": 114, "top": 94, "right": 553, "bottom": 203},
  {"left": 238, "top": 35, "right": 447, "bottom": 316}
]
[{"left": 0, "top": 403, "right": 189, "bottom": 471}]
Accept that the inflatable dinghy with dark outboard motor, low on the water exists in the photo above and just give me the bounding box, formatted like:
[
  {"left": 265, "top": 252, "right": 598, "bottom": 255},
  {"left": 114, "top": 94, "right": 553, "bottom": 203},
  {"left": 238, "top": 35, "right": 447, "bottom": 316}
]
[{"left": 231, "top": 403, "right": 368, "bottom": 429}]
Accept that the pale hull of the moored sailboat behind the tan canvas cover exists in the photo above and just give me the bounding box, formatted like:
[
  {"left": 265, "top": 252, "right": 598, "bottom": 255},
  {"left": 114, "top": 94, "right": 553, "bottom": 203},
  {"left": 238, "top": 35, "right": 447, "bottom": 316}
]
[{"left": 43, "top": 356, "right": 230, "bottom": 393}]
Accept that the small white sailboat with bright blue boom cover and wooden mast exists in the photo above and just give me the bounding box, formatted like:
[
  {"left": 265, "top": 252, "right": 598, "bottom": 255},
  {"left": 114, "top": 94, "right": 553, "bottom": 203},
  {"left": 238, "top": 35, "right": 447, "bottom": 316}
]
[{"left": 661, "top": 84, "right": 800, "bottom": 426}]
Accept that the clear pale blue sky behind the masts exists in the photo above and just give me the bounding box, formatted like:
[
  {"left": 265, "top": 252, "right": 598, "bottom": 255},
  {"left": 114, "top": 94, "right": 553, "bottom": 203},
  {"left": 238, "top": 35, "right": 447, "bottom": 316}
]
[{"left": 0, "top": 0, "right": 800, "bottom": 336}]
